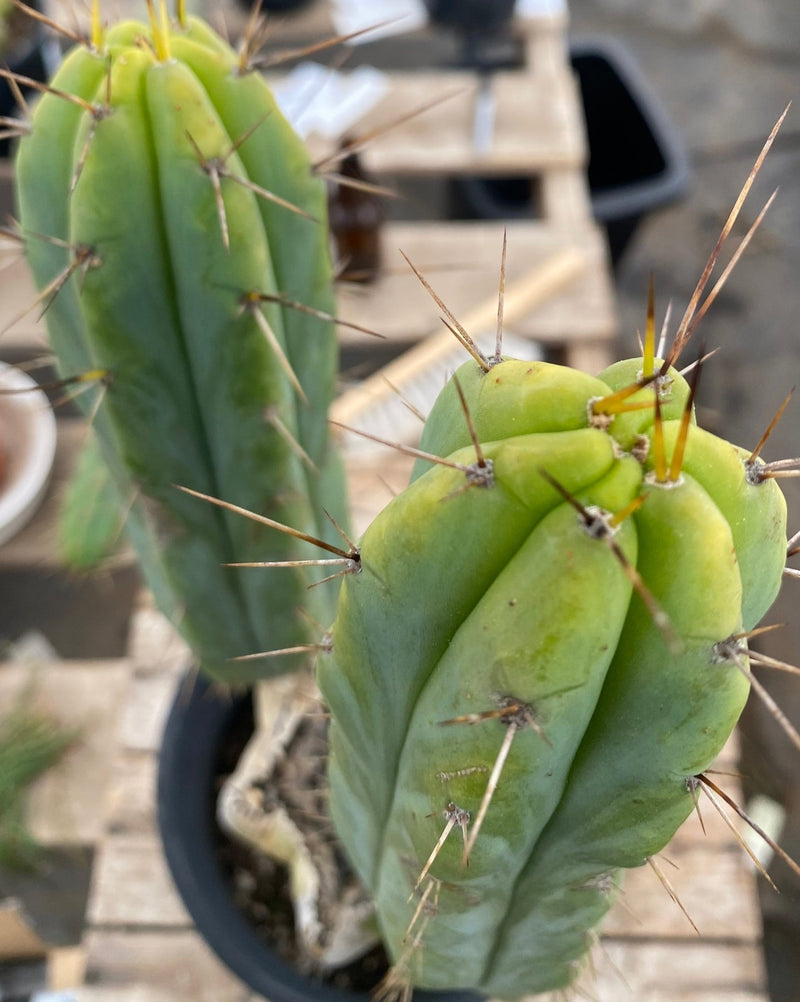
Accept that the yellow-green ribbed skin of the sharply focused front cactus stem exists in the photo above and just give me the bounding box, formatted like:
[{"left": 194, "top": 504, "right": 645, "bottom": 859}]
[{"left": 318, "top": 359, "right": 786, "bottom": 998}]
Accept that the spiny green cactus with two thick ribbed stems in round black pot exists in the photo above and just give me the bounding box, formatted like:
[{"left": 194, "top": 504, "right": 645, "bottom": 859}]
[{"left": 10, "top": 5, "right": 786, "bottom": 998}]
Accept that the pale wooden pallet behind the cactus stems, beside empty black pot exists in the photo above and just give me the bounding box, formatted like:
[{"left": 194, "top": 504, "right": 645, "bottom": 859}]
[{"left": 262, "top": 5, "right": 617, "bottom": 372}]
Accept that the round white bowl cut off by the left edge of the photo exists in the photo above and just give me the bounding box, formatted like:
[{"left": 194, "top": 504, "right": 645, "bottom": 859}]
[{"left": 0, "top": 362, "right": 56, "bottom": 545}]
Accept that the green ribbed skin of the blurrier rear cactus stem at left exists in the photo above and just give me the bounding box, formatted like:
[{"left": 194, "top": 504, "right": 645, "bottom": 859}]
[{"left": 16, "top": 11, "right": 345, "bottom": 681}]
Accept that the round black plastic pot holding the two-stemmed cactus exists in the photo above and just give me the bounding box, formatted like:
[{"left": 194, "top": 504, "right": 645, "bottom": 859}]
[{"left": 157, "top": 678, "right": 480, "bottom": 1002}]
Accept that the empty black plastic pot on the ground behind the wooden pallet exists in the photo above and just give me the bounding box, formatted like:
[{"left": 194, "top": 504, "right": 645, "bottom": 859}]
[{"left": 451, "top": 38, "right": 689, "bottom": 264}]
